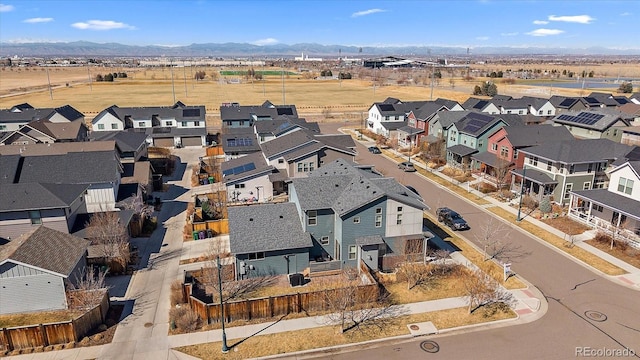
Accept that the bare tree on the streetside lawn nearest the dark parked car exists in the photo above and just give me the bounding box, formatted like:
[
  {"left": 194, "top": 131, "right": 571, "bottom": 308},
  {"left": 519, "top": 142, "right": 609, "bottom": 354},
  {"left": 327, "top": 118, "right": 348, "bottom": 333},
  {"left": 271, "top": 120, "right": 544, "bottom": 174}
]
[{"left": 475, "top": 217, "right": 529, "bottom": 262}]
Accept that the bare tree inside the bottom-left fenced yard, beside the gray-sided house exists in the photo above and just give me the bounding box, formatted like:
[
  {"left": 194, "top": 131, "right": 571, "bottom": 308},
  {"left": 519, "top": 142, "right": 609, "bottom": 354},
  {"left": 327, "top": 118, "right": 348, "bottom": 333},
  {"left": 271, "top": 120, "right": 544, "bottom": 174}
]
[{"left": 67, "top": 266, "right": 107, "bottom": 310}]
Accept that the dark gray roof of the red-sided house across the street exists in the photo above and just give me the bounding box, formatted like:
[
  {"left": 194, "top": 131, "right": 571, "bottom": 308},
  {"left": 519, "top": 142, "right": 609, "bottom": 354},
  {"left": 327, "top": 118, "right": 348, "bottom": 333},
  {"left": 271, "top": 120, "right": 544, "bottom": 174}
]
[{"left": 503, "top": 124, "right": 574, "bottom": 148}]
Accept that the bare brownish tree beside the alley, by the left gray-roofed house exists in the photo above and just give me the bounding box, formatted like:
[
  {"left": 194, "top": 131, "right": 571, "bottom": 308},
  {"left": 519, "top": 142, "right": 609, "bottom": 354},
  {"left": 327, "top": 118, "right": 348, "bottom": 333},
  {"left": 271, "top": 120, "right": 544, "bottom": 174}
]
[{"left": 87, "top": 211, "right": 130, "bottom": 270}]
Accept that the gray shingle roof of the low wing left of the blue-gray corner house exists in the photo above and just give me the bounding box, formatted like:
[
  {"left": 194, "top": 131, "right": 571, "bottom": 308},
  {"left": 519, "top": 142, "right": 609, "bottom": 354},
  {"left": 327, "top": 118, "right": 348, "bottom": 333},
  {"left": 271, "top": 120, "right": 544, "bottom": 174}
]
[{"left": 227, "top": 202, "right": 313, "bottom": 254}]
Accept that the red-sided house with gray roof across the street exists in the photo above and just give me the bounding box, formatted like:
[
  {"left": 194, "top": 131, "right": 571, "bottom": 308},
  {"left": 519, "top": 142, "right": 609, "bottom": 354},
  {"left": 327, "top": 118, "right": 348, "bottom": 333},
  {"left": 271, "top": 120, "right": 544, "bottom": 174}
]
[{"left": 471, "top": 124, "right": 574, "bottom": 184}]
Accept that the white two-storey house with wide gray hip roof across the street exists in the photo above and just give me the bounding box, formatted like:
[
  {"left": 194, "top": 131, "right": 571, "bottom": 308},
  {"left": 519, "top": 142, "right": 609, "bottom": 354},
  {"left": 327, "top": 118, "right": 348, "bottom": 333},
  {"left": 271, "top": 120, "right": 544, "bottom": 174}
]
[{"left": 511, "top": 139, "right": 633, "bottom": 205}]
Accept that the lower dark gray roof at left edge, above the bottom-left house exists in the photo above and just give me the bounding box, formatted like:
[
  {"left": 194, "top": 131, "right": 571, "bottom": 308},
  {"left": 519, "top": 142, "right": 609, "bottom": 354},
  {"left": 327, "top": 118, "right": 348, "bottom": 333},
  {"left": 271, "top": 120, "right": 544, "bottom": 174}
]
[{"left": 0, "top": 183, "right": 88, "bottom": 212}]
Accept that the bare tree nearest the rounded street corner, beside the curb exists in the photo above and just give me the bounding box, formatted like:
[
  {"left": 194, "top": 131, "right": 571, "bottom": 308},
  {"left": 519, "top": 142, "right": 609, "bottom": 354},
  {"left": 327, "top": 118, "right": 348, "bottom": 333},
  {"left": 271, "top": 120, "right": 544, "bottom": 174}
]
[{"left": 462, "top": 269, "right": 515, "bottom": 314}]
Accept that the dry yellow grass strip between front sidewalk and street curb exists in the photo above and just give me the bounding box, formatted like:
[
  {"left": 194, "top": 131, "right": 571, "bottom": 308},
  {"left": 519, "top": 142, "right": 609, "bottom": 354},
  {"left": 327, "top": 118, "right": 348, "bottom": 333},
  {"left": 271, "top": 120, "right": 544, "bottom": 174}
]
[{"left": 176, "top": 307, "right": 516, "bottom": 360}]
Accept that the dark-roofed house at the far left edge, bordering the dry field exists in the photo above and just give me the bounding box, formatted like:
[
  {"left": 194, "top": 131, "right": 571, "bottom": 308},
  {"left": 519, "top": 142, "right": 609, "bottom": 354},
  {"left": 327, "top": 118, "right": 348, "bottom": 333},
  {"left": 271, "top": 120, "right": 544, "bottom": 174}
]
[{"left": 0, "top": 103, "right": 84, "bottom": 132}]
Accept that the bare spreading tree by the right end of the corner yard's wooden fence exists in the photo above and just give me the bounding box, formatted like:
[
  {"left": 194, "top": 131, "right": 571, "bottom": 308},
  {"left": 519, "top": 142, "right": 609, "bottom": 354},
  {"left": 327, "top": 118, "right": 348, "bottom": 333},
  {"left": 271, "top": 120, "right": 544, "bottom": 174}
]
[{"left": 323, "top": 269, "right": 401, "bottom": 333}]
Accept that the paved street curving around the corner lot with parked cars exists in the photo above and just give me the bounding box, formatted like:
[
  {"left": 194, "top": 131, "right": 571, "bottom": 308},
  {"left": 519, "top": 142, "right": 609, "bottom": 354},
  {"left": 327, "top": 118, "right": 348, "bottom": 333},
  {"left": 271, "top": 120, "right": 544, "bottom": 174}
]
[{"left": 302, "top": 124, "right": 640, "bottom": 360}]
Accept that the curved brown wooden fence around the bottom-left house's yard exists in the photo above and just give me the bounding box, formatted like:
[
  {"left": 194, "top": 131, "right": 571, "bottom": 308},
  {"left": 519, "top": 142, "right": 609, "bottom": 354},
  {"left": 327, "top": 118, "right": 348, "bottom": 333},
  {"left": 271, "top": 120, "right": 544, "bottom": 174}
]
[{"left": 0, "top": 291, "right": 109, "bottom": 351}]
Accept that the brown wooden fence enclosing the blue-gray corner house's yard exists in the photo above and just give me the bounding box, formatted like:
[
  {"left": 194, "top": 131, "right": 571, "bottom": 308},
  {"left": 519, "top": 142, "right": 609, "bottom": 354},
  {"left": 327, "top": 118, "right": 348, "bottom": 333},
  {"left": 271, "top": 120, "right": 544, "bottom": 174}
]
[{"left": 184, "top": 262, "right": 379, "bottom": 324}]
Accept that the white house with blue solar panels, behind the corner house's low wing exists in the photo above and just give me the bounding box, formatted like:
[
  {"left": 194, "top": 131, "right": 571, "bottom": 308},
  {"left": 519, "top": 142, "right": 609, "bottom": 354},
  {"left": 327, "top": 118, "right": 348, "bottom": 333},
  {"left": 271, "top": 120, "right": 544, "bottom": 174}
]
[{"left": 221, "top": 152, "right": 276, "bottom": 202}]
